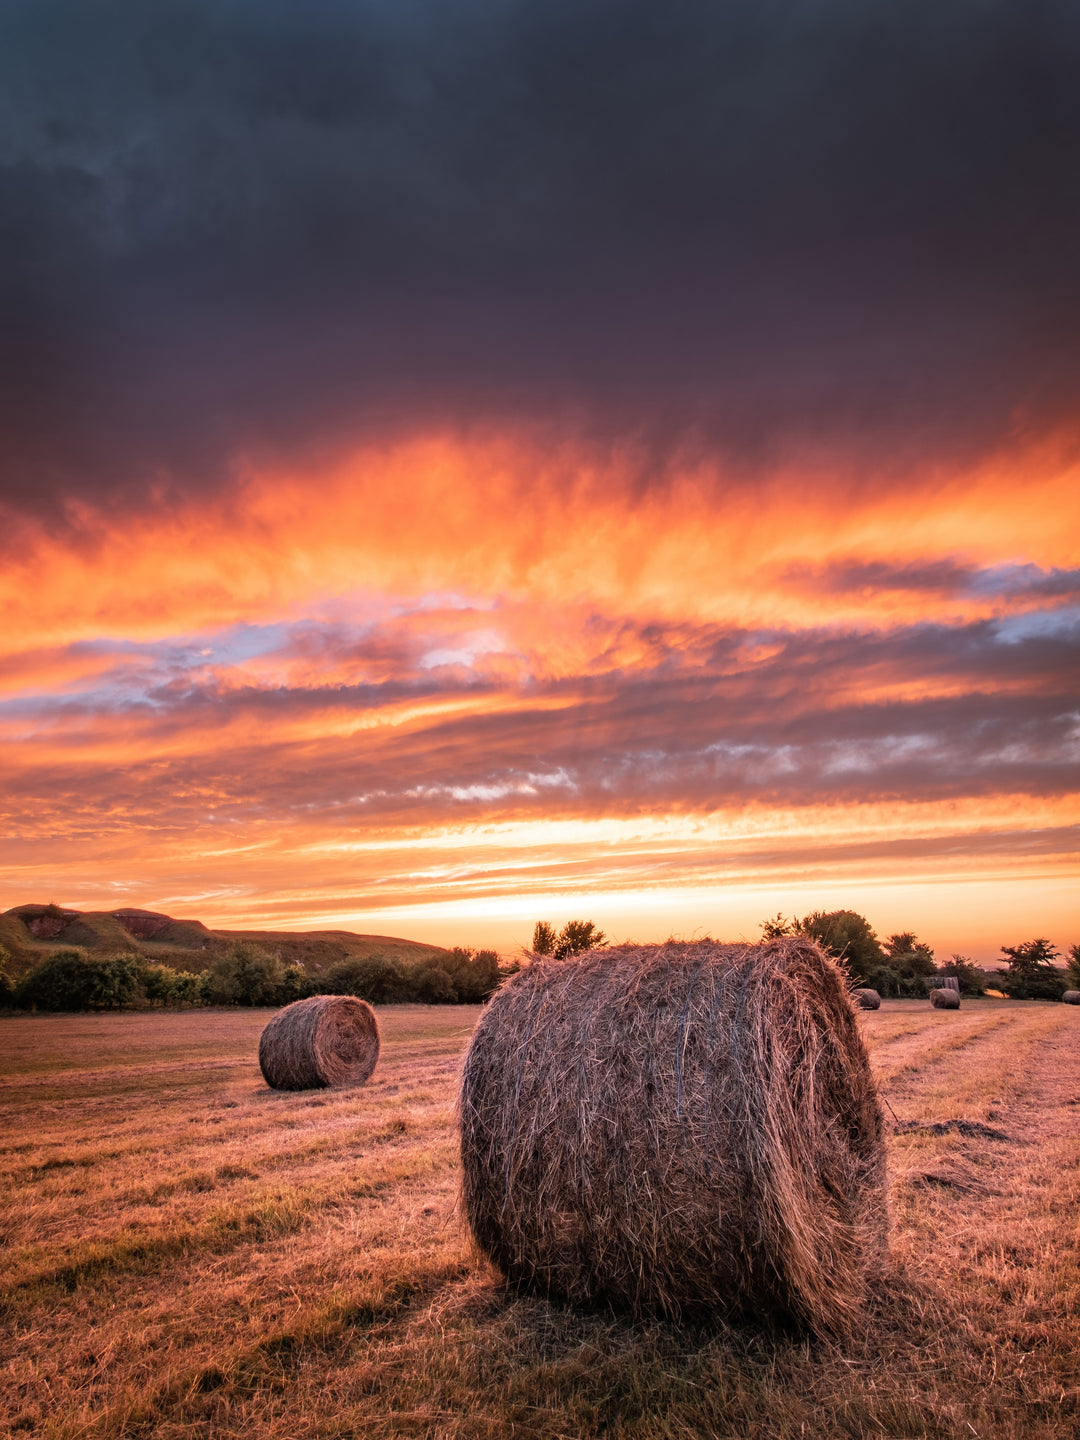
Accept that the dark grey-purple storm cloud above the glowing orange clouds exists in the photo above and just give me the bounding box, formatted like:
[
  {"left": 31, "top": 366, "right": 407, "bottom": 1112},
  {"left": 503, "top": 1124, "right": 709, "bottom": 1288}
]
[{"left": 0, "top": 0, "right": 1080, "bottom": 518}]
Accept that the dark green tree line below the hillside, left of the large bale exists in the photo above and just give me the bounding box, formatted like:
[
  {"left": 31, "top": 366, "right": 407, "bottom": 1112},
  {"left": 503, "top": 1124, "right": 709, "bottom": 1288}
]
[{"left": 0, "top": 940, "right": 504, "bottom": 1011}]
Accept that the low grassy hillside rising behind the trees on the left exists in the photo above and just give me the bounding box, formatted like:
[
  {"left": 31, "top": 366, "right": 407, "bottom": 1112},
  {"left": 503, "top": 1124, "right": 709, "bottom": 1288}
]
[{"left": 0, "top": 904, "right": 442, "bottom": 975}]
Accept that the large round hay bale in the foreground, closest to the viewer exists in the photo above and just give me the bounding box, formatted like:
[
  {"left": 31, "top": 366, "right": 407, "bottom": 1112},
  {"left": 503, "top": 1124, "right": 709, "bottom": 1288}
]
[{"left": 461, "top": 937, "right": 887, "bottom": 1331}]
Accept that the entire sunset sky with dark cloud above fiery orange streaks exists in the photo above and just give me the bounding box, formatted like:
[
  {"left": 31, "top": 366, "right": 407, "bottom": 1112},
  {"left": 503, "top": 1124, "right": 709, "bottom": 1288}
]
[{"left": 0, "top": 0, "right": 1080, "bottom": 959}]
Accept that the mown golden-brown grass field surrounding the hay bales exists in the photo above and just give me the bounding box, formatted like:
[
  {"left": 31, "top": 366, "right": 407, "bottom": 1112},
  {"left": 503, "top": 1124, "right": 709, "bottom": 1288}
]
[{"left": 0, "top": 999, "right": 1080, "bottom": 1440}]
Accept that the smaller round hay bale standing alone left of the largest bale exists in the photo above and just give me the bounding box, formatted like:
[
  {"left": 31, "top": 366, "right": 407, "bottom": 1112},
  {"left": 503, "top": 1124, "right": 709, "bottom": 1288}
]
[{"left": 259, "top": 995, "right": 379, "bottom": 1090}]
